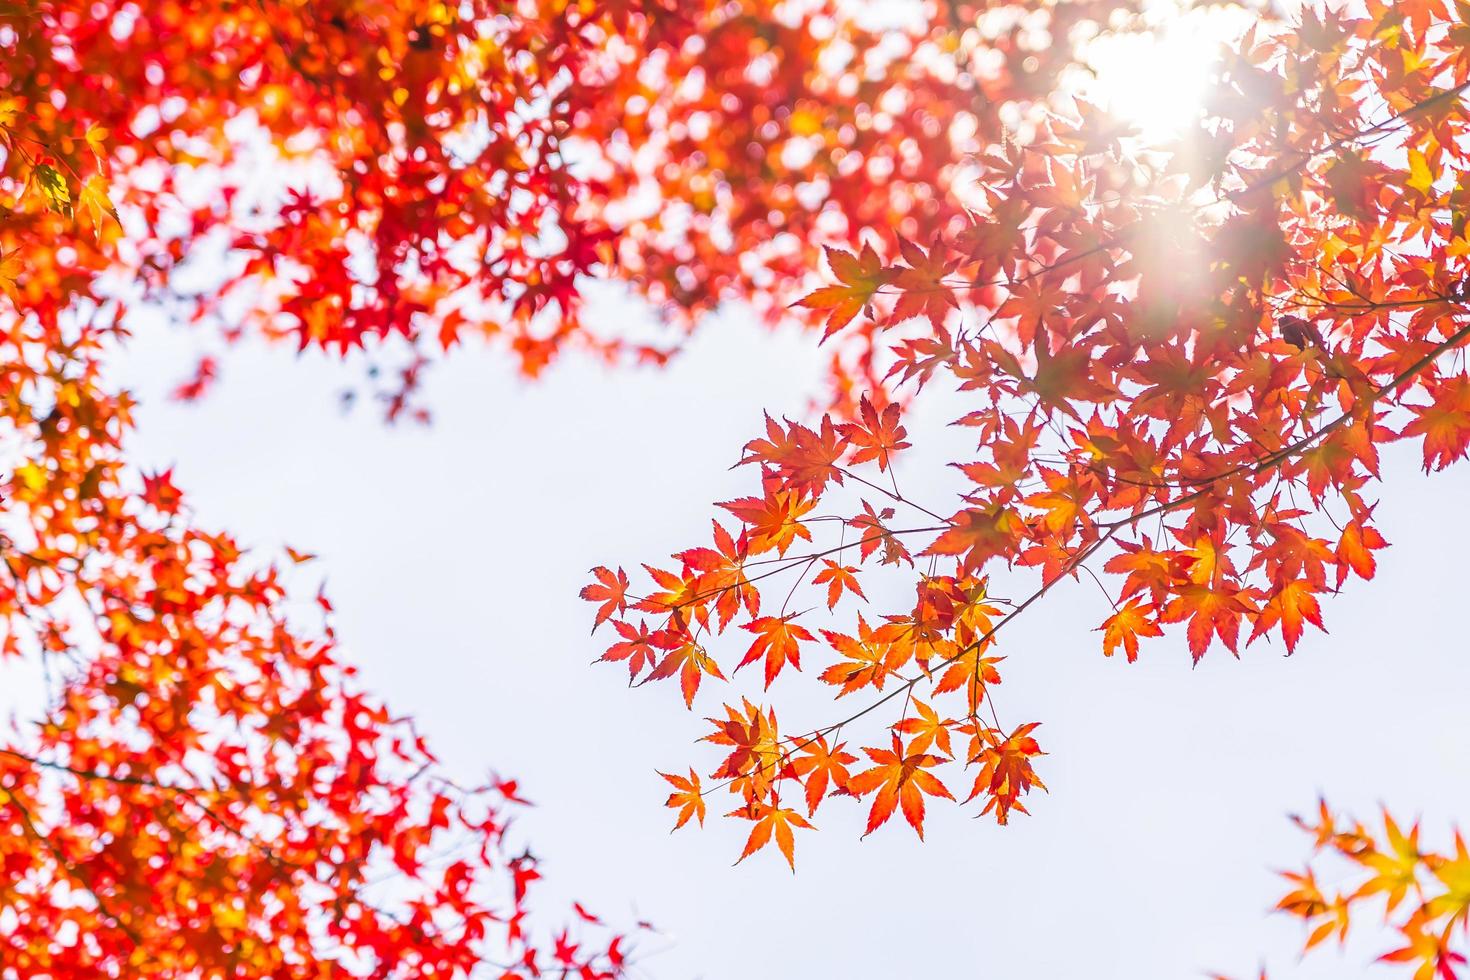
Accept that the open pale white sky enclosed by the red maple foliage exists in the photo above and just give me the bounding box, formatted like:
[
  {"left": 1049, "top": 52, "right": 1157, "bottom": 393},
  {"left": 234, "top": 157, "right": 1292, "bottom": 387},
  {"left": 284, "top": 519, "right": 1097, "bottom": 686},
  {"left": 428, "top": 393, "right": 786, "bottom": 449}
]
[{"left": 111, "top": 293, "right": 1470, "bottom": 980}]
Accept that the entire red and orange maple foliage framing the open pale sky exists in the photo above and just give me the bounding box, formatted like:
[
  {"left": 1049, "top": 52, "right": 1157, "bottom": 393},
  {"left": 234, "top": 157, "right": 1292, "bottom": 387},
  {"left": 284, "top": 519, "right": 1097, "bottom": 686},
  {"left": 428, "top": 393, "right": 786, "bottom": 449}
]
[{"left": 0, "top": 0, "right": 1470, "bottom": 980}]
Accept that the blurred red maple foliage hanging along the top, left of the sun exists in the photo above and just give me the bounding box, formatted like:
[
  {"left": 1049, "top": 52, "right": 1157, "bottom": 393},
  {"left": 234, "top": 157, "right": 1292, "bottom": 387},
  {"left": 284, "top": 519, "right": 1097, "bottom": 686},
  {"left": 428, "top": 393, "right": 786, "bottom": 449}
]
[{"left": 0, "top": 0, "right": 1141, "bottom": 417}]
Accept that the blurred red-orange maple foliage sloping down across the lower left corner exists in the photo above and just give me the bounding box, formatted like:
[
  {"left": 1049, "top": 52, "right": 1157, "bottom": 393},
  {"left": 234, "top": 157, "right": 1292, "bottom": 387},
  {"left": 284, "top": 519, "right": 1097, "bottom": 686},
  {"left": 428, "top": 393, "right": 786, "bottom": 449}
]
[{"left": 0, "top": 393, "right": 629, "bottom": 980}]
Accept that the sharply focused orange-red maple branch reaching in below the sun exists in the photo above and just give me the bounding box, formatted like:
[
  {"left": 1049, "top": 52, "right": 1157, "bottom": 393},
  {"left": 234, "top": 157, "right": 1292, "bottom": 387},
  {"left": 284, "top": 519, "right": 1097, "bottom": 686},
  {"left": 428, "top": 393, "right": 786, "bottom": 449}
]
[{"left": 585, "top": 0, "right": 1470, "bottom": 899}]
